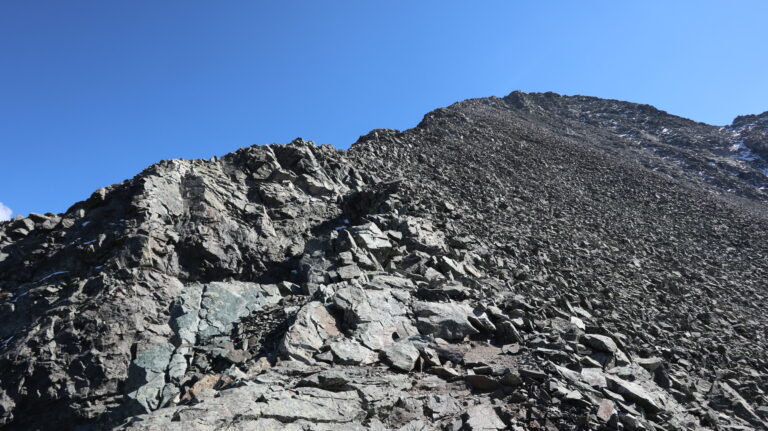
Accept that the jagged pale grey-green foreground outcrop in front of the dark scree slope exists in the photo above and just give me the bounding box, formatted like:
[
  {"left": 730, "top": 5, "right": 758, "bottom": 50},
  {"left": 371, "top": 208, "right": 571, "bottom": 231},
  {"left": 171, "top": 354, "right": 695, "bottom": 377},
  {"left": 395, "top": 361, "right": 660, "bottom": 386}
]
[{"left": 0, "top": 132, "right": 768, "bottom": 430}]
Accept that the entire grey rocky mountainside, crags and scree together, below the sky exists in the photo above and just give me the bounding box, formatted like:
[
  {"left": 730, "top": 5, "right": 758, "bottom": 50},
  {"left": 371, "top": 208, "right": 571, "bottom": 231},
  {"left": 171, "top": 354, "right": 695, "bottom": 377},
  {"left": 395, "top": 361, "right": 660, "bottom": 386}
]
[{"left": 0, "top": 92, "right": 768, "bottom": 430}]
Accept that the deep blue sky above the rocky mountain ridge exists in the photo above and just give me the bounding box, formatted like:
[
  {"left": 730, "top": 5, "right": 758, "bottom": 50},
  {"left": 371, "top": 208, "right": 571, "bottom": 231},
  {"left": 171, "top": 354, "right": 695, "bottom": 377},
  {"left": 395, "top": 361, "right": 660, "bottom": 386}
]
[{"left": 0, "top": 0, "right": 768, "bottom": 215}]
